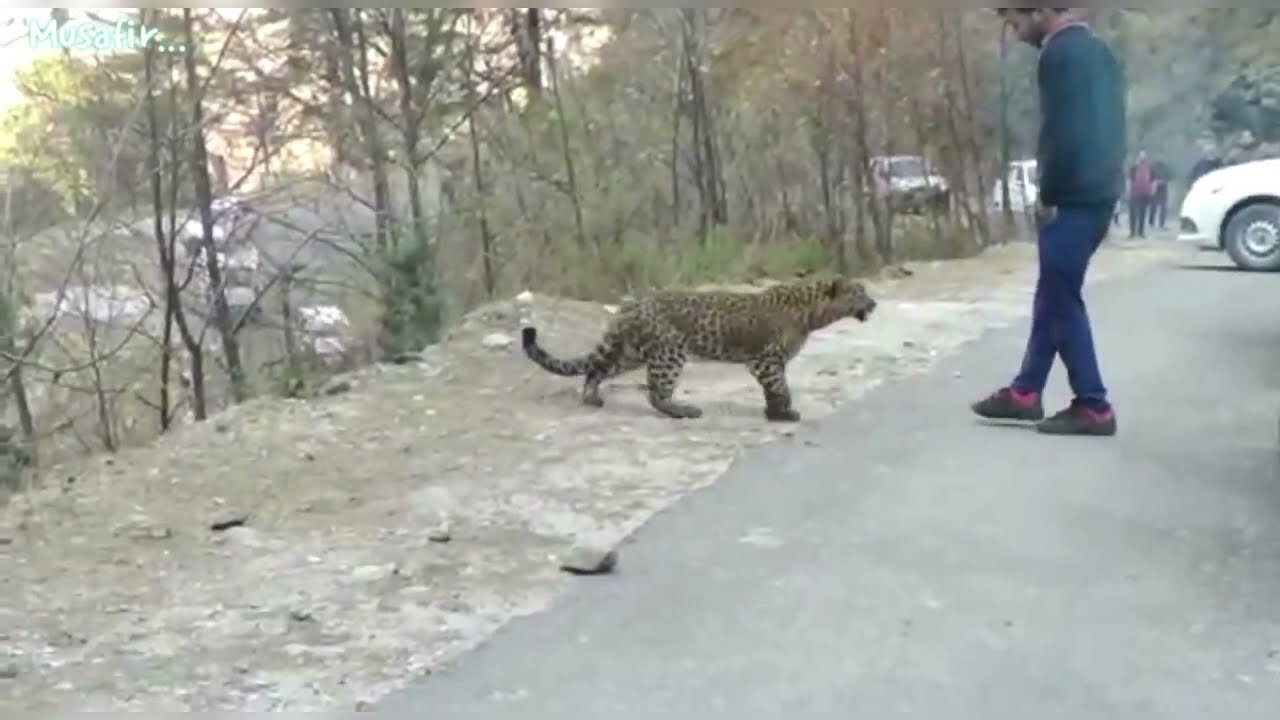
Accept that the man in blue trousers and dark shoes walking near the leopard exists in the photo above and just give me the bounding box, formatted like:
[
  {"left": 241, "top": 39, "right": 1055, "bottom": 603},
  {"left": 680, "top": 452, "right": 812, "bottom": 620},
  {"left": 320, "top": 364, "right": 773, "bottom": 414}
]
[{"left": 972, "top": 8, "right": 1125, "bottom": 437}]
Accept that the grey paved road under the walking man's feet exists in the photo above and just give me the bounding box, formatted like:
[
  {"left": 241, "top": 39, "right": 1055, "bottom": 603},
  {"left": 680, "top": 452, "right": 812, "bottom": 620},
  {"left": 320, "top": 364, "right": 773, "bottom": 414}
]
[{"left": 379, "top": 251, "right": 1280, "bottom": 720}]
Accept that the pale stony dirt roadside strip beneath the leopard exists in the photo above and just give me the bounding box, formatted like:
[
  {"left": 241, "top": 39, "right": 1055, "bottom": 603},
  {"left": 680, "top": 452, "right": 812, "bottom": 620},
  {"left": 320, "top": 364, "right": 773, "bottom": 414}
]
[{"left": 0, "top": 243, "right": 1181, "bottom": 714}]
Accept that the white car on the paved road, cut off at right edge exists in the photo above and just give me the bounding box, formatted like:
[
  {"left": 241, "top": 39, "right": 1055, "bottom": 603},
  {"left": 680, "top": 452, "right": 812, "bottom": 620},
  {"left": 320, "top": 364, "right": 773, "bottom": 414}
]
[{"left": 1178, "top": 159, "right": 1280, "bottom": 272}]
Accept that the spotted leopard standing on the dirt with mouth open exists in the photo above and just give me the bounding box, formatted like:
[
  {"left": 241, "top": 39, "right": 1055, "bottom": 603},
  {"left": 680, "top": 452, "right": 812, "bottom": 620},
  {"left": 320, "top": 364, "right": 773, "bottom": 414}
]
[{"left": 521, "top": 274, "right": 876, "bottom": 423}]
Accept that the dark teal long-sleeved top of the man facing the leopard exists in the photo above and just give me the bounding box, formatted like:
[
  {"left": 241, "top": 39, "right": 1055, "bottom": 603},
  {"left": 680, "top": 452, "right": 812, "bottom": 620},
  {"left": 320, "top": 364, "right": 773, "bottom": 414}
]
[{"left": 1038, "top": 24, "right": 1126, "bottom": 206}]
